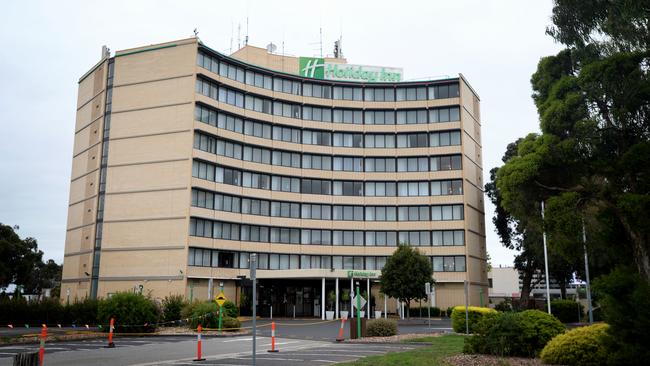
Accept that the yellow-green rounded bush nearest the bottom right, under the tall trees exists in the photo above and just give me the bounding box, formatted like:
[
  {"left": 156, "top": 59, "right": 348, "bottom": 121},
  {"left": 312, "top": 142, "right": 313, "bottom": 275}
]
[{"left": 540, "top": 324, "right": 609, "bottom": 366}]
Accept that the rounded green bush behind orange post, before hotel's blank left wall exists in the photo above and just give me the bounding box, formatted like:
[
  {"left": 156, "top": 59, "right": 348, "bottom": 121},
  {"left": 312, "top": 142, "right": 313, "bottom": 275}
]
[{"left": 97, "top": 292, "right": 160, "bottom": 333}]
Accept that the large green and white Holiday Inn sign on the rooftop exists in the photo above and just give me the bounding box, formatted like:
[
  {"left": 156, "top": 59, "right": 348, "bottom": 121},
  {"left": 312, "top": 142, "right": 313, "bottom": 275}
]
[{"left": 298, "top": 57, "right": 403, "bottom": 83}]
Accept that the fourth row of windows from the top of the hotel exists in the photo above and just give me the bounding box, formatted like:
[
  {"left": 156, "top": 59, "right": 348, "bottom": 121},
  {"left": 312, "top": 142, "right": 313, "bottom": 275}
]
[{"left": 194, "top": 132, "right": 462, "bottom": 172}]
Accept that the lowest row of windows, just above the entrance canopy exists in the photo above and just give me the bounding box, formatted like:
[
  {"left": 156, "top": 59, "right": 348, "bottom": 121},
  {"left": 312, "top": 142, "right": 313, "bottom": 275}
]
[{"left": 187, "top": 248, "right": 465, "bottom": 272}]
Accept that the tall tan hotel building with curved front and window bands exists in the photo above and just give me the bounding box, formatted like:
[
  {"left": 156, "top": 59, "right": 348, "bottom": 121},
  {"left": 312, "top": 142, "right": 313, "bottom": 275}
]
[{"left": 62, "top": 39, "right": 487, "bottom": 317}]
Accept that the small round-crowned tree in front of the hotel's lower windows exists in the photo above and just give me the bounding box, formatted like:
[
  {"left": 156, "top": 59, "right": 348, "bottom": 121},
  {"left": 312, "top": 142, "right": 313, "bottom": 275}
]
[{"left": 381, "top": 244, "right": 433, "bottom": 314}]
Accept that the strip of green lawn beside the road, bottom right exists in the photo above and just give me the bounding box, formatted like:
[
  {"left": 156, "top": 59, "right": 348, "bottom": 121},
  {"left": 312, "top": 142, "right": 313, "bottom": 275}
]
[{"left": 341, "top": 335, "right": 465, "bottom": 366}]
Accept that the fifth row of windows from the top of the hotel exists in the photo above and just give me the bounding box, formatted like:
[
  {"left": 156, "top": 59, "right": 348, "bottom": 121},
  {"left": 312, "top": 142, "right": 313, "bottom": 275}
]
[{"left": 192, "top": 160, "right": 463, "bottom": 197}]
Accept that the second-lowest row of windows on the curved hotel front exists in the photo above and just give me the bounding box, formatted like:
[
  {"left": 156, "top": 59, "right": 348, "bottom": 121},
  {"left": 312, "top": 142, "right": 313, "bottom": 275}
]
[{"left": 190, "top": 218, "right": 465, "bottom": 247}]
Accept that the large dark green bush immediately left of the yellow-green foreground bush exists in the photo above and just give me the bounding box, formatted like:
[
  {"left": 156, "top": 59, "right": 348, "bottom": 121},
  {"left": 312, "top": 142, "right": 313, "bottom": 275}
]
[{"left": 464, "top": 310, "right": 564, "bottom": 357}]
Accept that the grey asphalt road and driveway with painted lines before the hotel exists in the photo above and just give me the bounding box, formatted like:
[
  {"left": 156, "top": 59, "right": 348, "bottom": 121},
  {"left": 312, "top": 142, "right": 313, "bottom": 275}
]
[{"left": 0, "top": 319, "right": 450, "bottom": 366}]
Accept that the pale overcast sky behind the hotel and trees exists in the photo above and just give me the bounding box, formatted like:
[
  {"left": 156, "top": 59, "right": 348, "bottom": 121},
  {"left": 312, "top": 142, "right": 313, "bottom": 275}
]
[{"left": 0, "top": 0, "right": 560, "bottom": 265}]
